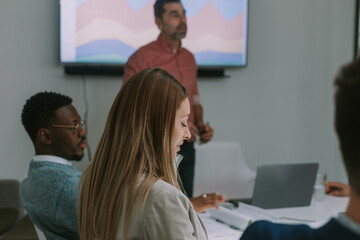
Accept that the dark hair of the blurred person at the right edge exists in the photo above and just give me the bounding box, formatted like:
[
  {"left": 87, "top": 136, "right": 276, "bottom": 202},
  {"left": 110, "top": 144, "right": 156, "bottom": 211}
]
[{"left": 335, "top": 58, "right": 360, "bottom": 195}]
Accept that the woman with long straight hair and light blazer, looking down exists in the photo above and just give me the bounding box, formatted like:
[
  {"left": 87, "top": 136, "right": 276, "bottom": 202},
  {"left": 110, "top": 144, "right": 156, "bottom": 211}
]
[{"left": 79, "top": 68, "right": 207, "bottom": 240}]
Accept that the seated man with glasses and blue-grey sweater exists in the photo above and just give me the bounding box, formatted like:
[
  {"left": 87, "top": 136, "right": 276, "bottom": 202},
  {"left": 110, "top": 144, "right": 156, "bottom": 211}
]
[{"left": 20, "top": 92, "right": 86, "bottom": 239}]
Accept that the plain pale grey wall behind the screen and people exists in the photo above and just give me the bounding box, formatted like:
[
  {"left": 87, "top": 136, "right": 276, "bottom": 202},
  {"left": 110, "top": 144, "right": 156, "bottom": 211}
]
[{"left": 0, "top": 0, "right": 355, "bottom": 185}]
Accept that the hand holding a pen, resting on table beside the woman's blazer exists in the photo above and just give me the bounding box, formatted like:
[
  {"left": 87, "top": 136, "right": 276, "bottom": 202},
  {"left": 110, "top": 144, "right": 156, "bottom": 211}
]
[{"left": 190, "top": 193, "right": 225, "bottom": 213}]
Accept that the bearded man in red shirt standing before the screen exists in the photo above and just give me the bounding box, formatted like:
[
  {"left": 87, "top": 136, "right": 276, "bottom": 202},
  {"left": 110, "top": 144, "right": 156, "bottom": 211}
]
[{"left": 123, "top": 0, "right": 214, "bottom": 197}]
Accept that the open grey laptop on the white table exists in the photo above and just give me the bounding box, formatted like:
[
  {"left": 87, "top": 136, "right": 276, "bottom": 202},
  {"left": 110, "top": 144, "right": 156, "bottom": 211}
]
[{"left": 230, "top": 163, "right": 319, "bottom": 209}]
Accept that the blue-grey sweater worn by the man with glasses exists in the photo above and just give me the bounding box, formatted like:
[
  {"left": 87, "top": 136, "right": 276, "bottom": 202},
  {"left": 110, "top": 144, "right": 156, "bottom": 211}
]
[{"left": 20, "top": 160, "right": 81, "bottom": 240}]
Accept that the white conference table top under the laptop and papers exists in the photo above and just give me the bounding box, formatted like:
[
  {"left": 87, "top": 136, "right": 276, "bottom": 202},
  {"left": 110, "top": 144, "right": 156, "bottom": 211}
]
[{"left": 200, "top": 195, "right": 349, "bottom": 240}]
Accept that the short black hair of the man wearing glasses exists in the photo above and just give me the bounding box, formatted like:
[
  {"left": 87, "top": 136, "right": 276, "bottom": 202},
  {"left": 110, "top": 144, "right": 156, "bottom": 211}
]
[{"left": 21, "top": 91, "right": 72, "bottom": 143}]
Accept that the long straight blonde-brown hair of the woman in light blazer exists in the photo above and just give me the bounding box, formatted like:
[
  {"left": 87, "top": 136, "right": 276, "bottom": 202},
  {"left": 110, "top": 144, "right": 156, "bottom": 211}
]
[{"left": 78, "top": 68, "right": 187, "bottom": 240}]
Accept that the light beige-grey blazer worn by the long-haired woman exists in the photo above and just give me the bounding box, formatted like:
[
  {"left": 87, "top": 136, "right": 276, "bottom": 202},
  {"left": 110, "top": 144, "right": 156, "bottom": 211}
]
[{"left": 117, "top": 180, "right": 208, "bottom": 240}]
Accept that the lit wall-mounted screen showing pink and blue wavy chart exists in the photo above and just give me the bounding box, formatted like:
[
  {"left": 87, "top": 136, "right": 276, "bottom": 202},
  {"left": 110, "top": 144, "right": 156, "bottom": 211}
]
[{"left": 60, "top": 0, "right": 248, "bottom": 67}]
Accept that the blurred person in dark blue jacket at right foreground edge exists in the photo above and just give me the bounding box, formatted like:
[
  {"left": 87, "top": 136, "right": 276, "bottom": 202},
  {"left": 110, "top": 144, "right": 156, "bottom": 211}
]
[{"left": 241, "top": 58, "right": 360, "bottom": 240}]
